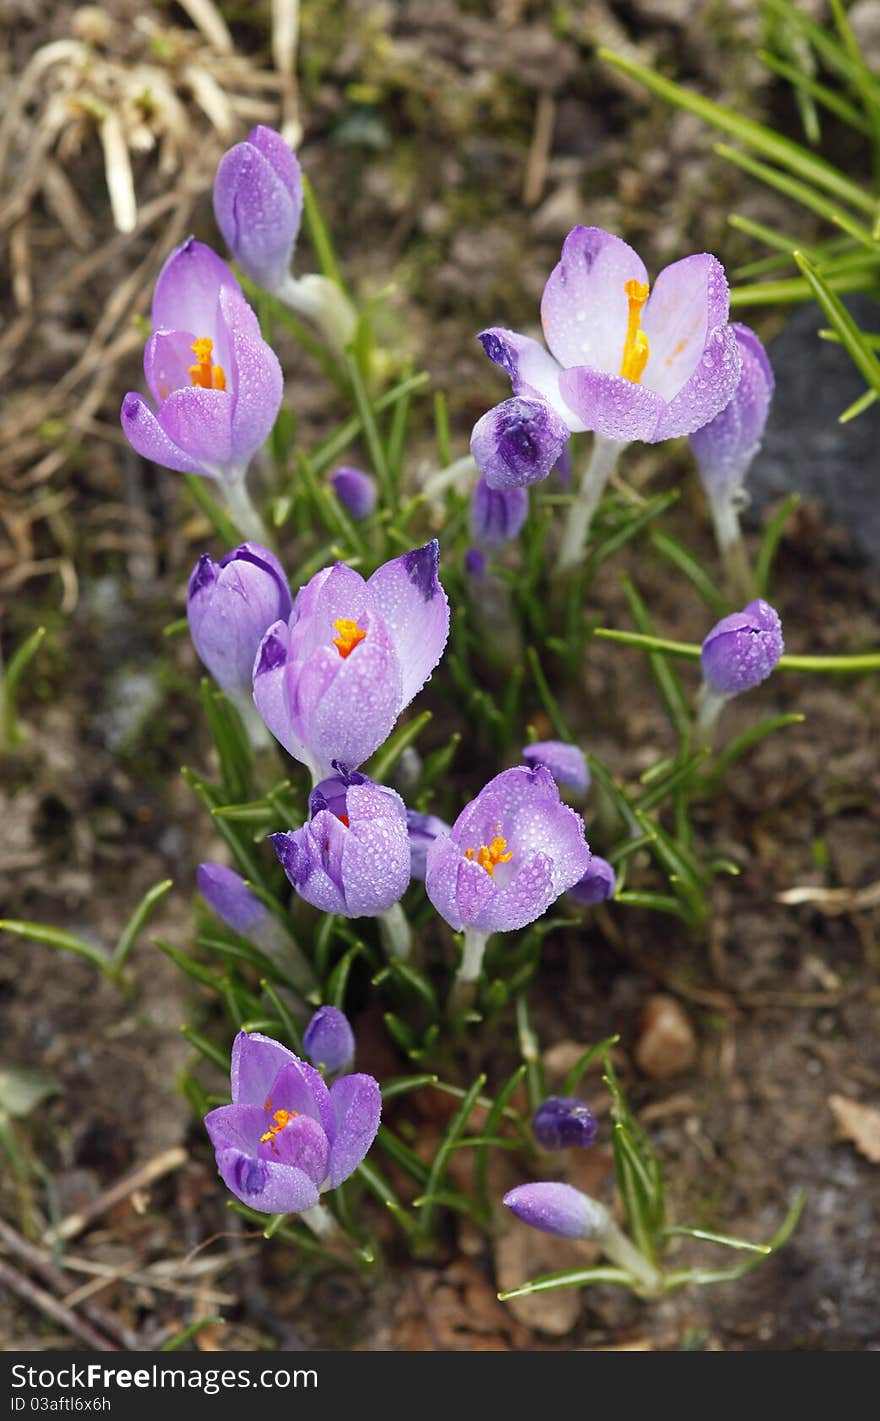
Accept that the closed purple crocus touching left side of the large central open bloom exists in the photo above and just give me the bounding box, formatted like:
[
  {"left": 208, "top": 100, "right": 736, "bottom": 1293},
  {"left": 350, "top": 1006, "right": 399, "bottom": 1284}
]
[{"left": 186, "top": 543, "right": 293, "bottom": 709}]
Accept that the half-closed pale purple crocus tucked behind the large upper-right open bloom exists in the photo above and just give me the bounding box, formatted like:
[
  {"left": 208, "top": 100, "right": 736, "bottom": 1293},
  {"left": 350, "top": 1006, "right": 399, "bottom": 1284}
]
[{"left": 691, "top": 323, "right": 773, "bottom": 499}]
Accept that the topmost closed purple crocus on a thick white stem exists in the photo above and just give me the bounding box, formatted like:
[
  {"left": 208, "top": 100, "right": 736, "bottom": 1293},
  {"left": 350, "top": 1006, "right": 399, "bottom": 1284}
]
[{"left": 213, "top": 125, "right": 303, "bottom": 291}]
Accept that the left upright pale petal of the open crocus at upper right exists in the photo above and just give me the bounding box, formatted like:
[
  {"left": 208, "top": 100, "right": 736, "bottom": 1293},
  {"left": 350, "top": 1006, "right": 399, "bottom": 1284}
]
[{"left": 540, "top": 227, "right": 648, "bottom": 375}]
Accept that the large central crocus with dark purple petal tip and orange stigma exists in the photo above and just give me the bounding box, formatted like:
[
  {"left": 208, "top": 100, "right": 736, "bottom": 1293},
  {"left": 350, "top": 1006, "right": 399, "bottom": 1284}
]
[{"left": 253, "top": 540, "right": 449, "bottom": 780}]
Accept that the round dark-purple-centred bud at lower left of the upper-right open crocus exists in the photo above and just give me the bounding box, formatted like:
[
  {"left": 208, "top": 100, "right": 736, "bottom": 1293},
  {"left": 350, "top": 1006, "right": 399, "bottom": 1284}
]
[{"left": 471, "top": 395, "right": 569, "bottom": 489}]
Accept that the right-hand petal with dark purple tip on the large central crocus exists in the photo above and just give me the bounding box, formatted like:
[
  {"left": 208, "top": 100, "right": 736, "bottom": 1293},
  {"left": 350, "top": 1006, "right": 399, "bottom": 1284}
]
[{"left": 366, "top": 539, "right": 449, "bottom": 710}]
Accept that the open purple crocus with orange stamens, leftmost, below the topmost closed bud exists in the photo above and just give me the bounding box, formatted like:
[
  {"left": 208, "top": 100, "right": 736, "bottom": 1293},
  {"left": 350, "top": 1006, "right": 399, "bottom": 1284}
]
[{"left": 121, "top": 237, "right": 281, "bottom": 485}]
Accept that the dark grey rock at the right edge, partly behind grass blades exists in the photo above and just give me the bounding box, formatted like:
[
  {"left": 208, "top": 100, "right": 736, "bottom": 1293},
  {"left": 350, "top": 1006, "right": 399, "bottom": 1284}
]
[{"left": 748, "top": 297, "right": 880, "bottom": 563}]
